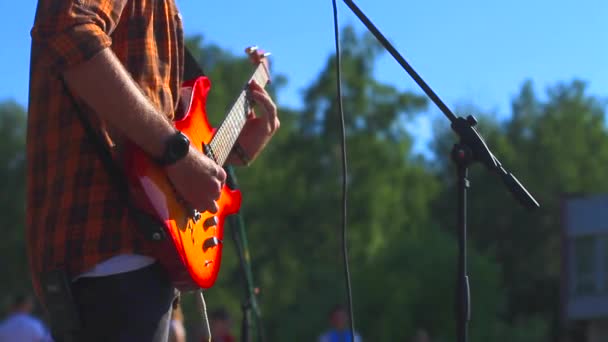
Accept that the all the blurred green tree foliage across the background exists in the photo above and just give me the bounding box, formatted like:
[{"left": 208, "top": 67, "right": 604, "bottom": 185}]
[{"left": 0, "top": 27, "right": 608, "bottom": 342}]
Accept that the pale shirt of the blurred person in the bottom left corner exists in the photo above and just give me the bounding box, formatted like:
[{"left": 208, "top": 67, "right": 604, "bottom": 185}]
[{"left": 0, "top": 313, "right": 52, "bottom": 342}]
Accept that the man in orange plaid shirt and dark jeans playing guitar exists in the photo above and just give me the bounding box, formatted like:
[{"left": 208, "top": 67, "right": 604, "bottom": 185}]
[{"left": 26, "top": 0, "right": 279, "bottom": 341}]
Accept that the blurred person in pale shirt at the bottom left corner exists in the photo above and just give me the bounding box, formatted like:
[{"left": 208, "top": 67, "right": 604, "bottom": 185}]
[{"left": 0, "top": 294, "right": 51, "bottom": 342}]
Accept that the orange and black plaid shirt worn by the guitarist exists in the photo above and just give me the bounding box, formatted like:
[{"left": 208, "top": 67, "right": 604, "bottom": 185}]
[{"left": 26, "top": 0, "right": 184, "bottom": 290}]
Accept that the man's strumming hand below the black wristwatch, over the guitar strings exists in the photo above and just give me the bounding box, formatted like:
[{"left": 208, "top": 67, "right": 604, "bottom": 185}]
[{"left": 166, "top": 146, "right": 226, "bottom": 213}]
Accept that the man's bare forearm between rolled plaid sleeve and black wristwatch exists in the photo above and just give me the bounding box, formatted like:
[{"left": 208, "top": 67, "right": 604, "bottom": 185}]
[{"left": 64, "top": 48, "right": 175, "bottom": 157}]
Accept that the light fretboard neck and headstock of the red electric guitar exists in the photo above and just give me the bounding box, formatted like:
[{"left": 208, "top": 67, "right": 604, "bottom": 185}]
[{"left": 209, "top": 63, "right": 269, "bottom": 166}]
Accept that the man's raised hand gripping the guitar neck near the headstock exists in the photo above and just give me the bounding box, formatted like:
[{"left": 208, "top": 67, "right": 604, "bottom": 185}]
[{"left": 233, "top": 81, "right": 280, "bottom": 161}]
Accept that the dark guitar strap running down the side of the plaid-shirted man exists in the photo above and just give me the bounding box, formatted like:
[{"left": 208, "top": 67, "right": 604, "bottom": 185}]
[{"left": 61, "top": 47, "right": 204, "bottom": 241}]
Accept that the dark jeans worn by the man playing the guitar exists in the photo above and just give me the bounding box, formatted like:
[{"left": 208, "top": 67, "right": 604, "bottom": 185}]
[{"left": 56, "top": 263, "right": 177, "bottom": 342}]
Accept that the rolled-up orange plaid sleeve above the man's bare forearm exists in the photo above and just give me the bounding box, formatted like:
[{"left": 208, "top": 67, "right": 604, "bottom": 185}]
[{"left": 31, "top": 0, "right": 128, "bottom": 72}]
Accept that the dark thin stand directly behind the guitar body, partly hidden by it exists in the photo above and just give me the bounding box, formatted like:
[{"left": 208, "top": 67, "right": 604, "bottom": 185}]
[{"left": 224, "top": 165, "right": 264, "bottom": 342}]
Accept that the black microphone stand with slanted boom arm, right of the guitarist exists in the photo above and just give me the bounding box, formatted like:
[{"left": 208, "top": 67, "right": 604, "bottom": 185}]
[{"left": 343, "top": 0, "right": 540, "bottom": 342}]
